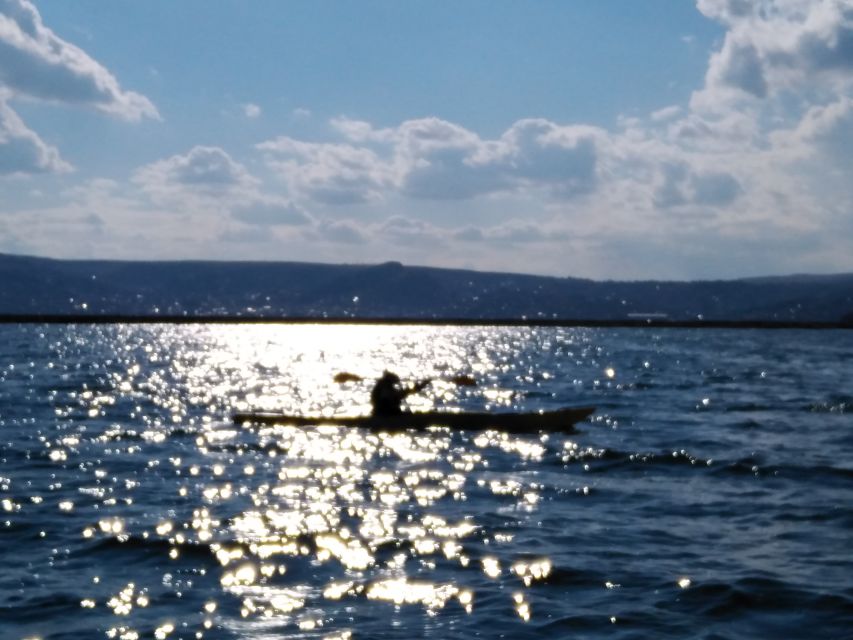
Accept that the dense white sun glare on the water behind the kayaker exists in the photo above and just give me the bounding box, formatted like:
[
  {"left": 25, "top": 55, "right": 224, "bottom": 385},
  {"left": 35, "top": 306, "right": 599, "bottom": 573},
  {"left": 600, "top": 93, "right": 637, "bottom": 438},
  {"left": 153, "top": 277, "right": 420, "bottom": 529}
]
[{"left": 184, "top": 324, "right": 500, "bottom": 415}]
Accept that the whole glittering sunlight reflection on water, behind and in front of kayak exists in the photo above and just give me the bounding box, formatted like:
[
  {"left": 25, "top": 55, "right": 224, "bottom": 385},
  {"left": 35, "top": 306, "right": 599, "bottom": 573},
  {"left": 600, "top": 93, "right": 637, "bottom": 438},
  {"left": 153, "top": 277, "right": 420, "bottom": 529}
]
[{"left": 58, "top": 324, "right": 572, "bottom": 639}]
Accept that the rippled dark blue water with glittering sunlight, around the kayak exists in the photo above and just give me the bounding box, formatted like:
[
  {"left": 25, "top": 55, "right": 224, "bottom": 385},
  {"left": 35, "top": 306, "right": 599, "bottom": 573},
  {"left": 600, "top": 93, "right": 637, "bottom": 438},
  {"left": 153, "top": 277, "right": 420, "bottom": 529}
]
[{"left": 0, "top": 325, "right": 853, "bottom": 639}]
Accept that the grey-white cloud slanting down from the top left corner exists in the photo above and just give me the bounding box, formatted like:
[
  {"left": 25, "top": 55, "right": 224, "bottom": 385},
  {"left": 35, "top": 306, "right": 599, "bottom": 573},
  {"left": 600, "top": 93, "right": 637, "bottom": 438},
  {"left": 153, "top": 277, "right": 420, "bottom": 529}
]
[{"left": 0, "top": 0, "right": 159, "bottom": 120}]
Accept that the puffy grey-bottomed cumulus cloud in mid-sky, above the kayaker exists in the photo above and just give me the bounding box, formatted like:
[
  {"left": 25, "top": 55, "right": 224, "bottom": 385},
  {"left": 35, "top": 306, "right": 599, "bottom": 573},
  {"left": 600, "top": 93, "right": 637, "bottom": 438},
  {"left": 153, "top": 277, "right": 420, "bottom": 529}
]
[{"left": 258, "top": 118, "right": 607, "bottom": 204}]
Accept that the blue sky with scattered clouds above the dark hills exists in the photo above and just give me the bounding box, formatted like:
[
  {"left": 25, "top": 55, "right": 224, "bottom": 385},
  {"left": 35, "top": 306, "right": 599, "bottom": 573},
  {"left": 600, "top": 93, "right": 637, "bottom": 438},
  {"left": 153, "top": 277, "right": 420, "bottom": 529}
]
[{"left": 0, "top": 0, "right": 853, "bottom": 280}]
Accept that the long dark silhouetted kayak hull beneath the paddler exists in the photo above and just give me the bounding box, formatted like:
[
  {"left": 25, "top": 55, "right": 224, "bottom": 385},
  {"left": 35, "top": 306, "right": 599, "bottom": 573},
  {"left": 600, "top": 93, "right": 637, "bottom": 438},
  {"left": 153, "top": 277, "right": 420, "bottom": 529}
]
[{"left": 233, "top": 407, "right": 595, "bottom": 433}]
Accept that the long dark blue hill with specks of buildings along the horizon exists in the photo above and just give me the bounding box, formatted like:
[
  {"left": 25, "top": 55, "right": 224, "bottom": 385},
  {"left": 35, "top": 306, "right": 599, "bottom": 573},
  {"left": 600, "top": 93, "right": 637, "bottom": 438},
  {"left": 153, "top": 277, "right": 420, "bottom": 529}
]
[{"left": 0, "top": 254, "right": 853, "bottom": 322}]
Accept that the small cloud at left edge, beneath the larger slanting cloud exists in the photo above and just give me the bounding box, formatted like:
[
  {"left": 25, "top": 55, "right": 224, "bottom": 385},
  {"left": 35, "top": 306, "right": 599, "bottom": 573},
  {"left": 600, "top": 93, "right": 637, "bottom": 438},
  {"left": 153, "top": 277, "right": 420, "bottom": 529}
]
[{"left": 0, "top": 93, "right": 71, "bottom": 176}]
